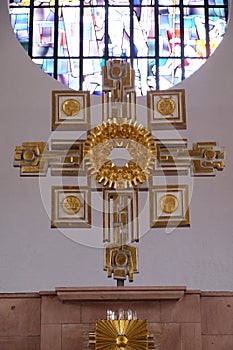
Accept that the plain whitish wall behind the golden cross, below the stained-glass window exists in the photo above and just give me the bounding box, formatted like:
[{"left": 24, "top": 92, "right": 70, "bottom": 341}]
[{"left": 0, "top": 1, "right": 233, "bottom": 292}]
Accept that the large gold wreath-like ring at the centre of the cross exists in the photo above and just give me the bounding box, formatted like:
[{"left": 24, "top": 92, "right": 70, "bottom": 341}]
[{"left": 84, "top": 120, "right": 156, "bottom": 189}]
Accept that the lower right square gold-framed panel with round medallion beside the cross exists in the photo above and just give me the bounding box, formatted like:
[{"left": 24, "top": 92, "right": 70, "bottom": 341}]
[{"left": 149, "top": 185, "right": 190, "bottom": 227}]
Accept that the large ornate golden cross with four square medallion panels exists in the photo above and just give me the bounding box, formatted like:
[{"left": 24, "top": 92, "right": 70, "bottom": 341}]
[{"left": 14, "top": 60, "right": 225, "bottom": 285}]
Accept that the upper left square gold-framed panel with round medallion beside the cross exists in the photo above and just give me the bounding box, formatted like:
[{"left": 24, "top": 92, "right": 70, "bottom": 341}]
[{"left": 52, "top": 90, "right": 90, "bottom": 131}]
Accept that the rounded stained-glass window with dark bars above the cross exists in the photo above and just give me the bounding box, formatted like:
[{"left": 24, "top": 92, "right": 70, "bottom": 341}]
[{"left": 9, "top": 0, "right": 228, "bottom": 95}]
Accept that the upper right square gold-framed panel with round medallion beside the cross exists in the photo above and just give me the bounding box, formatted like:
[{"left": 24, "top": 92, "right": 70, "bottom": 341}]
[{"left": 147, "top": 90, "right": 186, "bottom": 130}]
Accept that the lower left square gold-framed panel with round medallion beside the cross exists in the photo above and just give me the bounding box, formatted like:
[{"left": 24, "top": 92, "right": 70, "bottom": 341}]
[{"left": 51, "top": 186, "right": 91, "bottom": 228}]
